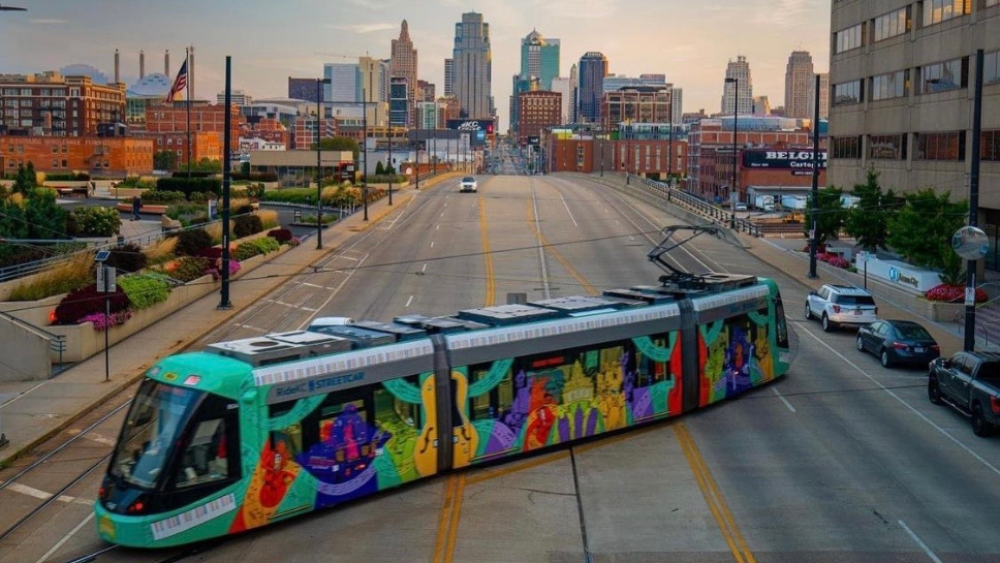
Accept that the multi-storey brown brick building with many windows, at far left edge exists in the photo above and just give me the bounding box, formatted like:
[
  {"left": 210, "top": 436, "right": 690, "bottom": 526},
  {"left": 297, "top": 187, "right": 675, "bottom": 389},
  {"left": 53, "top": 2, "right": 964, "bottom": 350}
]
[{"left": 0, "top": 72, "right": 125, "bottom": 137}]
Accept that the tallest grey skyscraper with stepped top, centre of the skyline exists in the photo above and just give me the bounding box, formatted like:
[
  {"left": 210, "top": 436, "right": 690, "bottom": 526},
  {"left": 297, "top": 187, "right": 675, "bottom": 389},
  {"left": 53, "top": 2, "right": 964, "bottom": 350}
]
[{"left": 453, "top": 12, "right": 493, "bottom": 119}]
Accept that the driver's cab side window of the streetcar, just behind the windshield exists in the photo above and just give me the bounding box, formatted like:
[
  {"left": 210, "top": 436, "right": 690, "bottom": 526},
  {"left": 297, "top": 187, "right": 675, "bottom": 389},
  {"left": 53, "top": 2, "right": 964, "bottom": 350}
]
[{"left": 173, "top": 395, "right": 239, "bottom": 489}]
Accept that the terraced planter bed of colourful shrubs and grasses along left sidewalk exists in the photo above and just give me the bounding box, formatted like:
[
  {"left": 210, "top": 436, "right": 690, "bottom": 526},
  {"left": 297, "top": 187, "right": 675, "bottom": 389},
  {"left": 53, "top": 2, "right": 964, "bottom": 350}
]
[{"left": 0, "top": 211, "right": 298, "bottom": 381}]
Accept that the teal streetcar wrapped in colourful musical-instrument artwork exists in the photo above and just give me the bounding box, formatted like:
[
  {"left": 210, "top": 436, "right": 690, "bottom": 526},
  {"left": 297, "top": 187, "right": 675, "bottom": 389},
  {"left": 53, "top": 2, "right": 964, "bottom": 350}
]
[{"left": 95, "top": 227, "right": 792, "bottom": 548}]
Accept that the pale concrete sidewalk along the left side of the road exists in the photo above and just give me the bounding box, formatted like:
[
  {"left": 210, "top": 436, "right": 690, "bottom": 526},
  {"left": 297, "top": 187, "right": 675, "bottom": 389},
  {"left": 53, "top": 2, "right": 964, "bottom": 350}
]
[{"left": 0, "top": 173, "right": 453, "bottom": 467}]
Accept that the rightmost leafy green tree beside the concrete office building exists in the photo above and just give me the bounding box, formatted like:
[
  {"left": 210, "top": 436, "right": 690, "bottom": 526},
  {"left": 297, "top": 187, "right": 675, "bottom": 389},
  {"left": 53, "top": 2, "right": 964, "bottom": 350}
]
[{"left": 888, "top": 188, "right": 969, "bottom": 270}]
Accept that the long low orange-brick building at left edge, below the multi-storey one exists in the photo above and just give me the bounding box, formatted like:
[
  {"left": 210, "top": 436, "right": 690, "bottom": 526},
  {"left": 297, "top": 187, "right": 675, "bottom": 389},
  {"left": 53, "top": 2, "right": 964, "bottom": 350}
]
[{"left": 0, "top": 135, "right": 155, "bottom": 177}]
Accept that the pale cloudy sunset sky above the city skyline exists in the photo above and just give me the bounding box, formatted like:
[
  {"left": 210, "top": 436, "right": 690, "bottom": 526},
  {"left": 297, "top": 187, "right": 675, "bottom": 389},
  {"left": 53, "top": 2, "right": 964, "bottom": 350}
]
[{"left": 0, "top": 0, "right": 830, "bottom": 130}]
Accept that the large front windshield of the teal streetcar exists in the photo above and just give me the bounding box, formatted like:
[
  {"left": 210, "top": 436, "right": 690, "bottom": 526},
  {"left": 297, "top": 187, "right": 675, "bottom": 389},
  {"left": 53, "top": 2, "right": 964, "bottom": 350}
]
[{"left": 110, "top": 379, "right": 204, "bottom": 489}]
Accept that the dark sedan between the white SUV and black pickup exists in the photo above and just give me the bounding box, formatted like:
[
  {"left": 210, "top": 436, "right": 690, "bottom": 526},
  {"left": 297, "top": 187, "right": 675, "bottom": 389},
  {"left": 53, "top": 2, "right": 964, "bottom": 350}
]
[{"left": 858, "top": 320, "right": 941, "bottom": 367}]
